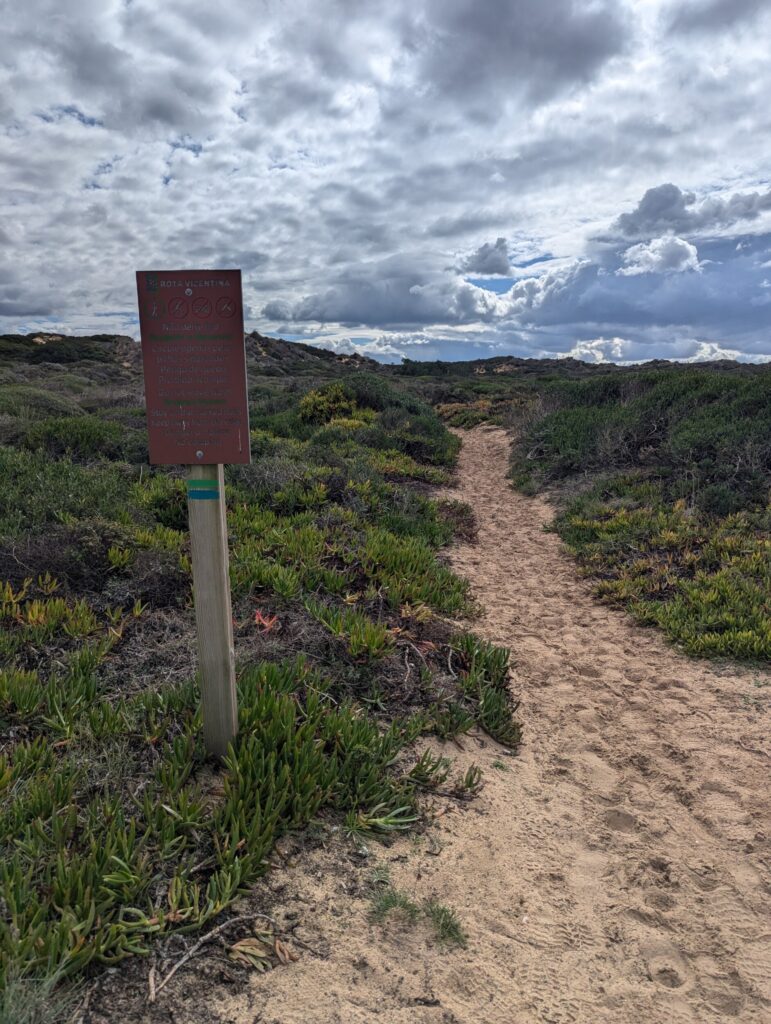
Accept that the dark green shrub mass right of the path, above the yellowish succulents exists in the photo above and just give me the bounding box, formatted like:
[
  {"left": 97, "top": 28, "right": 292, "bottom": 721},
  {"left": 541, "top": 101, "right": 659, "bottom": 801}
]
[{"left": 513, "top": 368, "right": 771, "bottom": 514}]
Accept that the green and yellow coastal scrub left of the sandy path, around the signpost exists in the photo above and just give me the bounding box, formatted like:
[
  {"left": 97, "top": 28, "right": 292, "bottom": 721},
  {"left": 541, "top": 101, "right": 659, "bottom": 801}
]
[{"left": 0, "top": 338, "right": 520, "bottom": 1003}]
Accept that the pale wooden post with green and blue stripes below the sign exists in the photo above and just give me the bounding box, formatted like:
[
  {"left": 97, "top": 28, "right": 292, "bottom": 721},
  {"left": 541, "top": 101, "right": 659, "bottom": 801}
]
[{"left": 187, "top": 465, "right": 239, "bottom": 759}]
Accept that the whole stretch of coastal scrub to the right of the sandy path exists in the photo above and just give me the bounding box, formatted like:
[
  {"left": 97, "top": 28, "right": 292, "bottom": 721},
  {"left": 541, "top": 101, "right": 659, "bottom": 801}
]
[{"left": 417, "top": 358, "right": 771, "bottom": 662}]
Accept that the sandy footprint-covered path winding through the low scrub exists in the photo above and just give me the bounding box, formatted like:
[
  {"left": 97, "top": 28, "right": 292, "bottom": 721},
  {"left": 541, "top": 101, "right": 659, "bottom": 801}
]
[{"left": 115, "top": 428, "right": 771, "bottom": 1024}]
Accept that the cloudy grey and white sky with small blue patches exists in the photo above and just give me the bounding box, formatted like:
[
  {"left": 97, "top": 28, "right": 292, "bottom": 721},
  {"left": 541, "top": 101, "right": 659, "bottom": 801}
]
[{"left": 0, "top": 0, "right": 771, "bottom": 361}]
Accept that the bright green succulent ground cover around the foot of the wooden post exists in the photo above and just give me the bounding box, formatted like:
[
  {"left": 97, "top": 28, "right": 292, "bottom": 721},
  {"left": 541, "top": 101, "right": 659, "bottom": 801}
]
[{"left": 0, "top": 659, "right": 434, "bottom": 978}]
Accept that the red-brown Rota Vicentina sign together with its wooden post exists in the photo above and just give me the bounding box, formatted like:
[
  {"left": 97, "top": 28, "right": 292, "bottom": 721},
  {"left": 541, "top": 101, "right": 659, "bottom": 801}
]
[{"left": 136, "top": 270, "right": 251, "bottom": 758}]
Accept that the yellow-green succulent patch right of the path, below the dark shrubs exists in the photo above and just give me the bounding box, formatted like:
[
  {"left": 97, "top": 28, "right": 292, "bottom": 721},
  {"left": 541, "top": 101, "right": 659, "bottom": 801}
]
[{"left": 555, "top": 475, "right": 771, "bottom": 660}]
